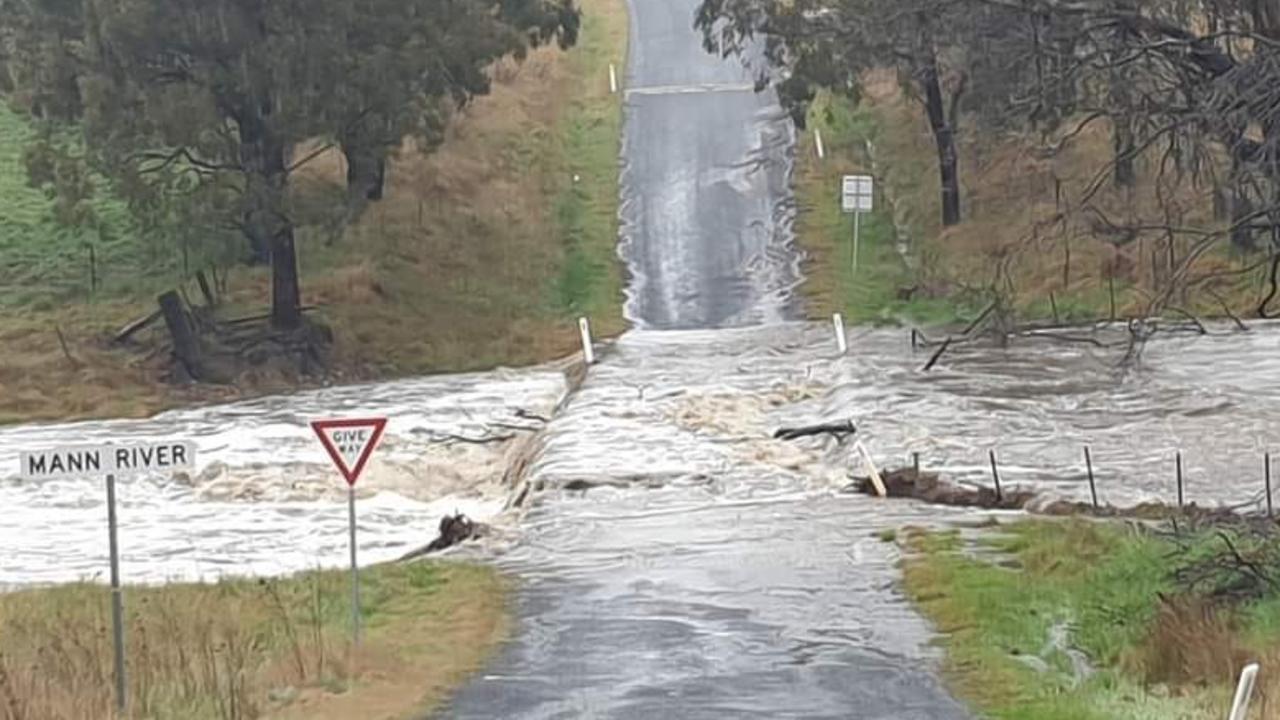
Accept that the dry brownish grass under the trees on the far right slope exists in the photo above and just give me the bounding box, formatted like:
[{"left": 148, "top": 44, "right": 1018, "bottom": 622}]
[{"left": 801, "top": 73, "right": 1263, "bottom": 319}]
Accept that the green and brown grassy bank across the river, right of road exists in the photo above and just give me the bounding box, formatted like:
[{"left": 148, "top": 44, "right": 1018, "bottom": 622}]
[{"left": 796, "top": 76, "right": 1265, "bottom": 324}]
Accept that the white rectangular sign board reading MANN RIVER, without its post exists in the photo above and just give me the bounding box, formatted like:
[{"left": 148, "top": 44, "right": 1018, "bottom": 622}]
[{"left": 18, "top": 441, "right": 196, "bottom": 480}]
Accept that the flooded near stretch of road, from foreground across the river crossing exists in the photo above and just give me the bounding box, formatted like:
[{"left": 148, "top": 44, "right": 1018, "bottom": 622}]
[{"left": 442, "top": 324, "right": 966, "bottom": 720}]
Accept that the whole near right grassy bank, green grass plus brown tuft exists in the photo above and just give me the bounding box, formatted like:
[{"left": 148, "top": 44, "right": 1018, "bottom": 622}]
[{"left": 904, "top": 520, "right": 1280, "bottom": 720}]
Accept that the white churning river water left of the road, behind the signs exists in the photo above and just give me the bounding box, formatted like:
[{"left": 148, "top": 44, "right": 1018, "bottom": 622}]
[{"left": 0, "top": 369, "right": 566, "bottom": 587}]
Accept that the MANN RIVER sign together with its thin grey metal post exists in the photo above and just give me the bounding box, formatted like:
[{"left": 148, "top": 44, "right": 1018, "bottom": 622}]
[{"left": 18, "top": 441, "right": 196, "bottom": 715}]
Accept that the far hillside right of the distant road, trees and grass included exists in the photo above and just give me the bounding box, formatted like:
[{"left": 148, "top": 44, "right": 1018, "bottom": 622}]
[{"left": 696, "top": 0, "right": 1280, "bottom": 330}]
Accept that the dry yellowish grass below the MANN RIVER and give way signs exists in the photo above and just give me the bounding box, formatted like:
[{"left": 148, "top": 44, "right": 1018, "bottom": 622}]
[{"left": 0, "top": 562, "right": 507, "bottom": 720}]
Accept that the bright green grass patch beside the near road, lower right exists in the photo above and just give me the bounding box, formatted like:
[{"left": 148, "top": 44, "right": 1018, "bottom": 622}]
[{"left": 904, "top": 521, "right": 1218, "bottom": 720}]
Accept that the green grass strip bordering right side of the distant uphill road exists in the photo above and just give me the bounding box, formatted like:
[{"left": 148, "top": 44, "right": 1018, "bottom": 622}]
[{"left": 796, "top": 94, "right": 973, "bottom": 325}]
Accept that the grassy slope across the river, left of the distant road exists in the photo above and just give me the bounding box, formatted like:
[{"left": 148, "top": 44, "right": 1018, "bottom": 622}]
[{"left": 0, "top": 0, "right": 627, "bottom": 423}]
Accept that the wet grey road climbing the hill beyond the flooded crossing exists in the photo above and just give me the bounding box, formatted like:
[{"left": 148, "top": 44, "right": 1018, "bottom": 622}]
[{"left": 622, "top": 0, "right": 799, "bottom": 329}]
